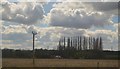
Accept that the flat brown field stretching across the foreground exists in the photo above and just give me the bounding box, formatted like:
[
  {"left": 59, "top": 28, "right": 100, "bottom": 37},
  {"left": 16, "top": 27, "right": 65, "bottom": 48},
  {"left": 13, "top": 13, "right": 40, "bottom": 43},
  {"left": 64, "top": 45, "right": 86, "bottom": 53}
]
[{"left": 2, "top": 59, "right": 119, "bottom": 68}]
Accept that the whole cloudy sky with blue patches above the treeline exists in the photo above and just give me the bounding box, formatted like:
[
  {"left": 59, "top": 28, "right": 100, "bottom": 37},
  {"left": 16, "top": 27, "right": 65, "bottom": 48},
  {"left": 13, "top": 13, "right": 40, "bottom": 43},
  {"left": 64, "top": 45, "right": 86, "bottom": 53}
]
[{"left": 0, "top": 0, "right": 120, "bottom": 50}]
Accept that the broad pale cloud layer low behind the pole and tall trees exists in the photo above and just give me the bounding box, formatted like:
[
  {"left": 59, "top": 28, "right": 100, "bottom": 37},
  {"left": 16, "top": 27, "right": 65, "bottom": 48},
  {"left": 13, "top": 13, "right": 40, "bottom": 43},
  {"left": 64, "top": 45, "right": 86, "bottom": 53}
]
[{"left": 2, "top": 25, "right": 118, "bottom": 50}]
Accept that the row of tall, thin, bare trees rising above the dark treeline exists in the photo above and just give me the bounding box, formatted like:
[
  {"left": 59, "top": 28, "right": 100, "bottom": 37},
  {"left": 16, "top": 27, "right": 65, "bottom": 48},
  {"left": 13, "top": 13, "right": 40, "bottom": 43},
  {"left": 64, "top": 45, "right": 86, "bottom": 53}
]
[{"left": 58, "top": 36, "right": 103, "bottom": 50}]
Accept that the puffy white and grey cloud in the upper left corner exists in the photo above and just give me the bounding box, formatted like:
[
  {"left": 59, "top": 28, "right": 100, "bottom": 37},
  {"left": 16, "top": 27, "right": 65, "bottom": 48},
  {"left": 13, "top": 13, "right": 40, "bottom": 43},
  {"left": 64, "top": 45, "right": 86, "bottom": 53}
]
[{"left": 2, "top": 2, "right": 44, "bottom": 25}]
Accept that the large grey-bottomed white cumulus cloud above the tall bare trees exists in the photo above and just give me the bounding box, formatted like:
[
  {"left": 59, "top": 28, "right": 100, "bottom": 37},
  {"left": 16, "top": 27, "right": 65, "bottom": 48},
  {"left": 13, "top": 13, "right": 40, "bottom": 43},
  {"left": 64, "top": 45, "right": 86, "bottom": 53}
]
[{"left": 46, "top": 2, "right": 111, "bottom": 29}]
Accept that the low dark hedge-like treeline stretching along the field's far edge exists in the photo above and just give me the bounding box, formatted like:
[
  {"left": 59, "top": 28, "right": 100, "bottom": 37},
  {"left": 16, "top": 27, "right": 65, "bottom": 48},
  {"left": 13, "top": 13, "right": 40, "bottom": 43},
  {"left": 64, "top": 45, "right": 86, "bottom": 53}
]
[{"left": 2, "top": 49, "right": 120, "bottom": 59}]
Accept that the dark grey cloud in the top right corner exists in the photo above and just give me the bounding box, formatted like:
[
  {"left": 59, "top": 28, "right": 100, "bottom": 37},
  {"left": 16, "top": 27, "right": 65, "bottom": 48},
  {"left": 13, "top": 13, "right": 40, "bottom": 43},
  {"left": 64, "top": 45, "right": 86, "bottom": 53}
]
[{"left": 84, "top": 2, "right": 118, "bottom": 15}]
